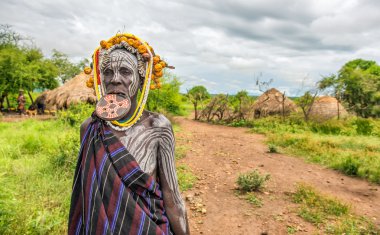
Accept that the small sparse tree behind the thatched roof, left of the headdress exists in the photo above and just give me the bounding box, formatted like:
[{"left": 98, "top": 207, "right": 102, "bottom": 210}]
[{"left": 52, "top": 49, "right": 81, "bottom": 83}]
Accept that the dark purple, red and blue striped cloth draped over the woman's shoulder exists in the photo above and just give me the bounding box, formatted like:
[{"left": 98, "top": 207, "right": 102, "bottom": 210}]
[{"left": 68, "top": 115, "right": 172, "bottom": 235}]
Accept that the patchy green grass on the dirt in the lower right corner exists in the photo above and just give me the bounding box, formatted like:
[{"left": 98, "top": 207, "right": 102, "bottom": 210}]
[{"left": 291, "top": 184, "right": 380, "bottom": 234}]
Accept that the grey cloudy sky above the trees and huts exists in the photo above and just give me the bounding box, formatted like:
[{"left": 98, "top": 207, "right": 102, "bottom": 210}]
[{"left": 0, "top": 0, "right": 380, "bottom": 95}]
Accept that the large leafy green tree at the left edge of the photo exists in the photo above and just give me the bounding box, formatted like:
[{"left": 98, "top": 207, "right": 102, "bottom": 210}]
[{"left": 0, "top": 26, "right": 58, "bottom": 108}]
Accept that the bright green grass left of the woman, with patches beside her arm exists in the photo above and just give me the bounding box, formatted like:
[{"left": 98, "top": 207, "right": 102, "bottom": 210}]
[{"left": 0, "top": 105, "right": 196, "bottom": 234}]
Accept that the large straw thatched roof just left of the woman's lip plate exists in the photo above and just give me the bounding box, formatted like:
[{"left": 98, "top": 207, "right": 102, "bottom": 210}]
[{"left": 36, "top": 72, "right": 96, "bottom": 110}]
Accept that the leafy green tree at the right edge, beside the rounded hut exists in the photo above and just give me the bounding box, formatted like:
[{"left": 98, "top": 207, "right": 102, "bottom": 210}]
[{"left": 319, "top": 59, "right": 380, "bottom": 117}]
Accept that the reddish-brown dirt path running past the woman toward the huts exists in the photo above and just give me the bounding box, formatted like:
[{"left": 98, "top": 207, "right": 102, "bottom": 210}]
[{"left": 176, "top": 118, "right": 380, "bottom": 234}]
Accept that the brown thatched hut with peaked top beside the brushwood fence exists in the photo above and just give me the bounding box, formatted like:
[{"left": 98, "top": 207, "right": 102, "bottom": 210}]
[{"left": 253, "top": 88, "right": 297, "bottom": 118}]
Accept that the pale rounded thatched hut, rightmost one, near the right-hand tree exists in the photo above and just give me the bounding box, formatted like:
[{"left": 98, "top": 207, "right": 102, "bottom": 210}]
[{"left": 309, "top": 96, "right": 348, "bottom": 120}]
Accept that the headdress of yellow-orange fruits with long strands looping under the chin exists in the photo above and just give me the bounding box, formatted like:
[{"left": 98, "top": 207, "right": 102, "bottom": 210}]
[{"left": 84, "top": 33, "right": 167, "bottom": 130}]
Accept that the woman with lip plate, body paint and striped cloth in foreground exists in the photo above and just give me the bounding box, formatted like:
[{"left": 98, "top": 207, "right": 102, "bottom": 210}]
[{"left": 68, "top": 34, "right": 190, "bottom": 235}]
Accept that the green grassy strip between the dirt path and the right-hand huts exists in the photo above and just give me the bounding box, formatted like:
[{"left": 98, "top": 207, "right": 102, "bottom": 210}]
[{"left": 249, "top": 117, "right": 380, "bottom": 183}]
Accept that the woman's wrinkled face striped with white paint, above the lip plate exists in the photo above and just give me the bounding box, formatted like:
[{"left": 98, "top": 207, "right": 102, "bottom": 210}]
[{"left": 100, "top": 49, "right": 140, "bottom": 98}]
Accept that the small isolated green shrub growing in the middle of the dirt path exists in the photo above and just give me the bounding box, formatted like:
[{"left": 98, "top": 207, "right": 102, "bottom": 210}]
[{"left": 236, "top": 169, "right": 270, "bottom": 192}]
